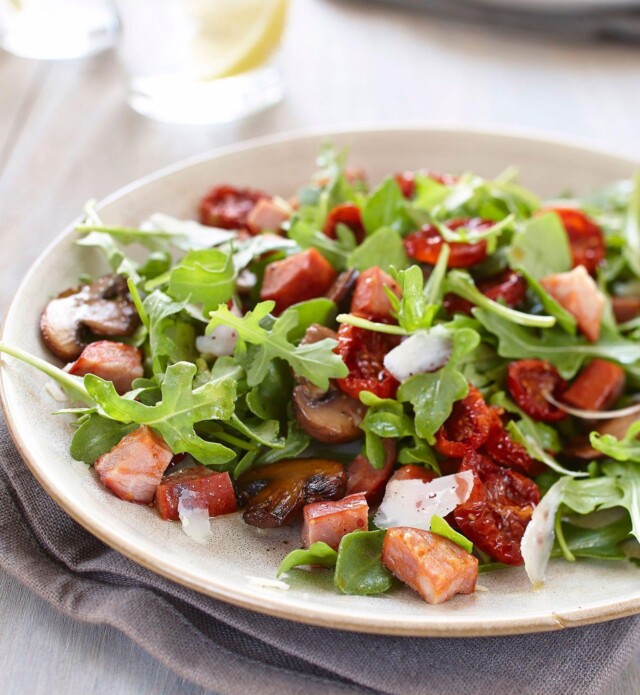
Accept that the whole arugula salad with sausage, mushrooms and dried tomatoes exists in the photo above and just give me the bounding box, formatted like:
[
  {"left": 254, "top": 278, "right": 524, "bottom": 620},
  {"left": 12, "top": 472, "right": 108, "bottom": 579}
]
[{"left": 0, "top": 146, "right": 640, "bottom": 604}]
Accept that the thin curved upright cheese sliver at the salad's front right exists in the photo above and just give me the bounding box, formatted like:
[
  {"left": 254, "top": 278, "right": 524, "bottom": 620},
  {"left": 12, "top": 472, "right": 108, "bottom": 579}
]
[{"left": 520, "top": 477, "right": 570, "bottom": 588}]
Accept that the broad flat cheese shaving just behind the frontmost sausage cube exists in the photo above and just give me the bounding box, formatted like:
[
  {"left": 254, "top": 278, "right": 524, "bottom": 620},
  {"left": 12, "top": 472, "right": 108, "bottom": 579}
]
[{"left": 374, "top": 471, "right": 474, "bottom": 531}]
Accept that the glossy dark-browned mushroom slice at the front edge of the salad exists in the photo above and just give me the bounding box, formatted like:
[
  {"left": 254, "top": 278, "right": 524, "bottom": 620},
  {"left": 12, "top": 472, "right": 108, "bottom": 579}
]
[{"left": 237, "top": 459, "right": 347, "bottom": 528}]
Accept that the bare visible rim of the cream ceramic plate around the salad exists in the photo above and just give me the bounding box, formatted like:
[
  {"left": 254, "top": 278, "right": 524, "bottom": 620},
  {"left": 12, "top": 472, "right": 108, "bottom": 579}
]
[{"left": 1, "top": 127, "right": 640, "bottom": 636}]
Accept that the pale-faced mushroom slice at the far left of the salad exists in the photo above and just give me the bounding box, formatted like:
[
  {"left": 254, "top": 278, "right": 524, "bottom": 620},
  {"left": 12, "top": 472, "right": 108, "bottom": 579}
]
[{"left": 40, "top": 275, "right": 139, "bottom": 362}]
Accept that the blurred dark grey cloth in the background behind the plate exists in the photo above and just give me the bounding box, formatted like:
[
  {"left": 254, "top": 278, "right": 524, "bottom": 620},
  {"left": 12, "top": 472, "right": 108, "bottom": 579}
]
[{"left": 362, "top": 0, "right": 640, "bottom": 43}]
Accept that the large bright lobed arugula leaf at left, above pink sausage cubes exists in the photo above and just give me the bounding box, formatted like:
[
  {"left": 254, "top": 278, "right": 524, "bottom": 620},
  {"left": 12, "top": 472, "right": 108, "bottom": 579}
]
[{"left": 84, "top": 362, "right": 241, "bottom": 466}]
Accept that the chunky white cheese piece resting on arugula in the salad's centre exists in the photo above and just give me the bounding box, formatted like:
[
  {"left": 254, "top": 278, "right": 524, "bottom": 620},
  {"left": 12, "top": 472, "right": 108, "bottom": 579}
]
[{"left": 384, "top": 326, "right": 453, "bottom": 383}]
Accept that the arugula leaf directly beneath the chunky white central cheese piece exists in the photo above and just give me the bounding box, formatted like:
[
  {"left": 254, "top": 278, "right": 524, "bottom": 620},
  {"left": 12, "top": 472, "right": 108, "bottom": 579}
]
[{"left": 398, "top": 328, "right": 480, "bottom": 444}]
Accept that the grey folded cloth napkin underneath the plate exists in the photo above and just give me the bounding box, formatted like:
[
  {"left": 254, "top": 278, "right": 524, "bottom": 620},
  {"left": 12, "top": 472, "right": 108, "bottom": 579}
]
[{"left": 0, "top": 418, "right": 640, "bottom": 695}]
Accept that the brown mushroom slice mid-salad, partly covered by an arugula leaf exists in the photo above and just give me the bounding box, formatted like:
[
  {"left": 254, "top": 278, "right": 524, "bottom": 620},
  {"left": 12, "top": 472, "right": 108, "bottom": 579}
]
[{"left": 293, "top": 324, "right": 367, "bottom": 444}]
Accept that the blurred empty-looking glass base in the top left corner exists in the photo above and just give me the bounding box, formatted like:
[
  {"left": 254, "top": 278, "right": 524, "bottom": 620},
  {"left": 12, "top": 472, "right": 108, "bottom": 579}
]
[{"left": 0, "top": 0, "right": 120, "bottom": 60}]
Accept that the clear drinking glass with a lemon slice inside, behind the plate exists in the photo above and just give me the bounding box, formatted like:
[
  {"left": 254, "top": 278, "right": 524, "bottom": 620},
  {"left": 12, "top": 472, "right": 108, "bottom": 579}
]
[{"left": 121, "top": 0, "right": 288, "bottom": 124}]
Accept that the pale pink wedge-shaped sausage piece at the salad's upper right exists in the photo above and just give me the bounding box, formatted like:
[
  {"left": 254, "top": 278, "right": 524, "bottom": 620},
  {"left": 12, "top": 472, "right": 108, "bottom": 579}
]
[{"left": 540, "top": 265, "right": 605, "bottom": 343}]
